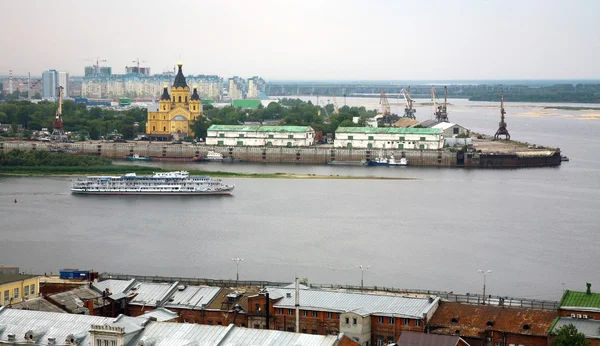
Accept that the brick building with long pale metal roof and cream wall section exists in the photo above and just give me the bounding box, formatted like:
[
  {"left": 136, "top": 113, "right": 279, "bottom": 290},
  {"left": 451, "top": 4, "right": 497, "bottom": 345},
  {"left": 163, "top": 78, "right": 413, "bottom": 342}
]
[{"left": 247, "top": 286, "right": 439, "bottom": 346}]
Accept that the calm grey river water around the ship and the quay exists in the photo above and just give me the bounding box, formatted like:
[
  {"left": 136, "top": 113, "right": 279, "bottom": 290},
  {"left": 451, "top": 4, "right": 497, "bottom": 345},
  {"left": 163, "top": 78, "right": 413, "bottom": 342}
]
[{"left": 0, "top": 98, "right": 600, "bottom": 299}]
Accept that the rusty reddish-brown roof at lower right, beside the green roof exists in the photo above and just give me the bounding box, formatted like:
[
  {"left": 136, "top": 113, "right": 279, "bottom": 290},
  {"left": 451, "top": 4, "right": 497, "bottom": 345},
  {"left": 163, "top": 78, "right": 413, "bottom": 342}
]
[{"left": 429, "top": 302, "right": 557, "bottom": 337}]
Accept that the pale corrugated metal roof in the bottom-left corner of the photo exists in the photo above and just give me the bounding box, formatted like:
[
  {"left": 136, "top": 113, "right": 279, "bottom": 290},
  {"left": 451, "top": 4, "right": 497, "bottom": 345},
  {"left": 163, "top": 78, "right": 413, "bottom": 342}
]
[{"left": 0, "top": 307, "right": 114, "bottom": 345}]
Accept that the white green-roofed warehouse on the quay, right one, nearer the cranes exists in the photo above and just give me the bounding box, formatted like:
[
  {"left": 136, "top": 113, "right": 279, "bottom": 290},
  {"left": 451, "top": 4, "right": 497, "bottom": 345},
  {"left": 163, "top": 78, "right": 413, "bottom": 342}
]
[{"left": 333, "top": 127, "right": 444, "bottom": 150}]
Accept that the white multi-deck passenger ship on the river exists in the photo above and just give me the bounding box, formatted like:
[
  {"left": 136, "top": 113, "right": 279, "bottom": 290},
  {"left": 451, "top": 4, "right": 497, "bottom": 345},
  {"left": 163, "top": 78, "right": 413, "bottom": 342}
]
[{"left": 71, "top": 171, "right": 234, "bottom": 196}]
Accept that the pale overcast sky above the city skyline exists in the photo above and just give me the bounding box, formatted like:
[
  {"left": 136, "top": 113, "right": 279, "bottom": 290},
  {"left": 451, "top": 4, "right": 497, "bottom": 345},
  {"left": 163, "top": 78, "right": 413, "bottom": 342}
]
[{"left": 0, "top": 0, "right": 600, "bottom": 80}]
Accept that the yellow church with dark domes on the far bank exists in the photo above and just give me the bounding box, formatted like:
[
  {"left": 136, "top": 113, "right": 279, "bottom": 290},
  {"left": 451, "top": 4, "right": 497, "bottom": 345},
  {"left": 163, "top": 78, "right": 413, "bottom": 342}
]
[{"left": 146, "top": 61, "right": 202, "bottom": 140}]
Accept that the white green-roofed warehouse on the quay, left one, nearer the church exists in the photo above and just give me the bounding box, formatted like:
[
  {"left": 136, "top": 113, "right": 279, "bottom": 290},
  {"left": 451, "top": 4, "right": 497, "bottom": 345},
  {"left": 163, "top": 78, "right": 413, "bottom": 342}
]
[{"left": 206, "top": 125, "right": 315, "bottom": 147}]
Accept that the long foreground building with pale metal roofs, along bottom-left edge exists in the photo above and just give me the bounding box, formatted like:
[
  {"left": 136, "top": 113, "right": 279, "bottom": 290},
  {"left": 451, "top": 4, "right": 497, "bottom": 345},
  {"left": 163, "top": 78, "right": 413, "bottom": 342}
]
[{"left": 0, "top": 307, "right": 357, "bottom": 346}]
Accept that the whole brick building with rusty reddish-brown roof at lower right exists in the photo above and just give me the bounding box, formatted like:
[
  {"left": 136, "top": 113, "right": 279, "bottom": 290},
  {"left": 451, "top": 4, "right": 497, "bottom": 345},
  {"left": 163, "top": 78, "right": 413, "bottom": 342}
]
[{"left": 427, "top": 302, "right": 556, "bottom": 346}]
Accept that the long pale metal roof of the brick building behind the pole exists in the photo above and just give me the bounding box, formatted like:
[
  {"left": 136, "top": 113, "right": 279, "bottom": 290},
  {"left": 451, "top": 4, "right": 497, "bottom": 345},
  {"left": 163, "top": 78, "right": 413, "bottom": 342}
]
[{"left": 267, "top": 288, "right": 439, "bottom": 318}]
